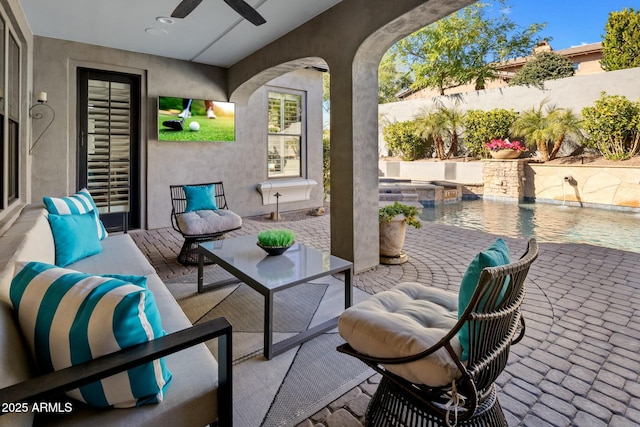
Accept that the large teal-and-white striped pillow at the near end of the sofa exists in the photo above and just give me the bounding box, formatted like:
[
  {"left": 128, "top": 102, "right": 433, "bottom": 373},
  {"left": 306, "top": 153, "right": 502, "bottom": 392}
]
[{"left": 10, "top": 262, "right": 171, "bottom": 408}]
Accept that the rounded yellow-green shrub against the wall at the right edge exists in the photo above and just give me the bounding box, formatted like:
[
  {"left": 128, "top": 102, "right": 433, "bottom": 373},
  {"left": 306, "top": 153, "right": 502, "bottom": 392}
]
[{"left": 582, "top": 92, "right": 640, "bottom": 160}]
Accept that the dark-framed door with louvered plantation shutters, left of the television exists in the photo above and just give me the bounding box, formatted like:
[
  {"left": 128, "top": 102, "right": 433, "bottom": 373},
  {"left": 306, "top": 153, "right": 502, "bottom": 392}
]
[{"left": 78, "top": 69, "right": 140, "bottom": 230}]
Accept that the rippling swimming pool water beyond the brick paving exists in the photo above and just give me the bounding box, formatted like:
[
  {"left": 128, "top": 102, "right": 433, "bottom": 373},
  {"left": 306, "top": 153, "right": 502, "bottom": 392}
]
[{"left": 420, "top": 200, "right": 640, "bottom": 252}]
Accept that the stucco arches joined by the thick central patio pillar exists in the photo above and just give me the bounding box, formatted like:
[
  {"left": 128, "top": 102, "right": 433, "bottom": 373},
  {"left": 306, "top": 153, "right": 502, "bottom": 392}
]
[{"left": 229, "top": 0, "right": 473, "bottom": 272}]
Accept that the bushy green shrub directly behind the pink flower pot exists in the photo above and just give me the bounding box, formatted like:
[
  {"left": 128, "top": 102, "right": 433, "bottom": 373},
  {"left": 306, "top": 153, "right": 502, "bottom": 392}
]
[{"left": 464, "top": 108, "right": 518, "bottom": 158}]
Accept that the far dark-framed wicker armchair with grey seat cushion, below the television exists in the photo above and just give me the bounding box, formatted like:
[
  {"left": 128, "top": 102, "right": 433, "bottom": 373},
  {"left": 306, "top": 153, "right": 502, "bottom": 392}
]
[{"left": 169, "top": 182, "right": 242, "bottom": 265}]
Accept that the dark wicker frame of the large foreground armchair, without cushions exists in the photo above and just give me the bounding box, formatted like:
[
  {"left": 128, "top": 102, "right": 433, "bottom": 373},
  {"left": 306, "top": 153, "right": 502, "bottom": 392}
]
[{"left": 338, "top": 239, "right": 538, "bottom": 427}]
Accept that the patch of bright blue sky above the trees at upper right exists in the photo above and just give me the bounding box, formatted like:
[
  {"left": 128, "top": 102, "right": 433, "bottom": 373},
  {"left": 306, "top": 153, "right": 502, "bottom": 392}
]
[{"left": 502, "top": 0, "right": 640, "bottom": 50}]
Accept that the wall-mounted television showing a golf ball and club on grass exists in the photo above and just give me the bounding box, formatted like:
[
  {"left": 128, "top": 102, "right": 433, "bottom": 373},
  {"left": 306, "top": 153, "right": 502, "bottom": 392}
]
[{"left": 158, "top": 96, "right": 236, "bottom": 142}]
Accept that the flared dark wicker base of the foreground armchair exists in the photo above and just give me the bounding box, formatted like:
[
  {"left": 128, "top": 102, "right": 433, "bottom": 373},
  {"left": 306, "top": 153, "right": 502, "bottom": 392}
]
[{"left": 365, "top": 377, "right": 508, "bottom": 427}]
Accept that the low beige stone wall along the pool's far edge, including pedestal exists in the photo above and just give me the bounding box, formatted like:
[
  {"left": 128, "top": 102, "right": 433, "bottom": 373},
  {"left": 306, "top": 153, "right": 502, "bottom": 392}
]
[{"left": 379, "top": 159, "right": 640, "bottom": 212}]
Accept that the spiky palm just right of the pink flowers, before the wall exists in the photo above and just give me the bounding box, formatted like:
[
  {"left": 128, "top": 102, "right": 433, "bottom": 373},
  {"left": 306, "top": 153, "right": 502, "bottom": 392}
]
[{"left": 511, "top": 99, "right": 558, "bottom": 161}]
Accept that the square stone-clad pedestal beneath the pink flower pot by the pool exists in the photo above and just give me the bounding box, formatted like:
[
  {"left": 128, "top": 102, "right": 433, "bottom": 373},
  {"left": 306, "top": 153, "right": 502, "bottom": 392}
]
[{"left": 482, "top": 159, "right": 527, "bottom": 202}]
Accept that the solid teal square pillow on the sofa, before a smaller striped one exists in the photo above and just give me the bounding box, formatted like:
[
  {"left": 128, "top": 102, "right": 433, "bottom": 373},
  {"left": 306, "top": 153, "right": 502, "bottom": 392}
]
[{"left": 49, "top": 212, "right": 102, "bottom": 267}]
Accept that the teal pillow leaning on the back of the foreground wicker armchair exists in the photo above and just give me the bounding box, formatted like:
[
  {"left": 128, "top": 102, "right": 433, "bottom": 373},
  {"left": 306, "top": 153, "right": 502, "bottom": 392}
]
[{"left": 458, "top": 239, "right": 509, "bottom": 361}]
